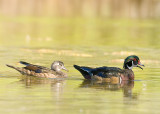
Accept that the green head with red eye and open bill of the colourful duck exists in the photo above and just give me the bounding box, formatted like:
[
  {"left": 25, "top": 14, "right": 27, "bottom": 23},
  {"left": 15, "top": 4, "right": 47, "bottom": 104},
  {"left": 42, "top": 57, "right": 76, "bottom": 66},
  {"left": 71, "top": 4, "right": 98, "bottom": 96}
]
[{"left": 123, "top": 55, "right": 144, "bottom": 70}]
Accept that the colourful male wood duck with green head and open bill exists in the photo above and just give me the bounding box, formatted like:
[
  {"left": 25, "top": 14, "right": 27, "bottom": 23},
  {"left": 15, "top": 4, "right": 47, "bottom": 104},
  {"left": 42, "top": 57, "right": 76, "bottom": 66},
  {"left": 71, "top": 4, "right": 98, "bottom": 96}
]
[{"left": 74, "top": 55, "right": 144, "bottom": 82}]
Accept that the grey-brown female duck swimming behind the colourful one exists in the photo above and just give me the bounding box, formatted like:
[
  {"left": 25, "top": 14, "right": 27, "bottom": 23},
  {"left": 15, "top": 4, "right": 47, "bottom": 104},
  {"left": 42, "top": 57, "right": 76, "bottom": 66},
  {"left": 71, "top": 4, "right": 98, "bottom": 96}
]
[{"left": 7, "top": 61, "right": 68, "bottom": 78}]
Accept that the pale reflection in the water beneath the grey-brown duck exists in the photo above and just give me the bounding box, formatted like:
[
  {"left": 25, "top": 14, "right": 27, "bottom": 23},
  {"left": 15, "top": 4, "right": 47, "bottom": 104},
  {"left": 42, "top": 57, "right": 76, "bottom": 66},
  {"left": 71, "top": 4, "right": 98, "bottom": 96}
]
[{"left": 20, "top": 76, "right": 66, "bottom": 100}]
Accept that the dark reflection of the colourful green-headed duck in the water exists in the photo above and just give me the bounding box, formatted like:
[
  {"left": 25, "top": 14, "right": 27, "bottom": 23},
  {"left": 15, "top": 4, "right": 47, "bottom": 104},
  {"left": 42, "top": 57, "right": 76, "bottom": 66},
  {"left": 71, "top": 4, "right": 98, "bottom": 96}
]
[{"left": 80, "top": 80, "right": 137, "bottom": 99}]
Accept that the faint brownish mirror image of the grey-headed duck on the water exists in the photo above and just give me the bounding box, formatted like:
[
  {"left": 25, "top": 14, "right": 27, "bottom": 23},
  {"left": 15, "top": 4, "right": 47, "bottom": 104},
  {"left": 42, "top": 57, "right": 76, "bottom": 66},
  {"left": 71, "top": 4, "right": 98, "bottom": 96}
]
[{"left": 16, "top": 76, "right": 66, "bottom": 101}]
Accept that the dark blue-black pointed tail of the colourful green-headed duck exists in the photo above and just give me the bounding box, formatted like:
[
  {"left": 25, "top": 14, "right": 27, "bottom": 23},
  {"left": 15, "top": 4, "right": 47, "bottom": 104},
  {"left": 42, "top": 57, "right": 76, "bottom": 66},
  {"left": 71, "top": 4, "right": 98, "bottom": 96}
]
[{"left": 73, "top": 65, "right": 93, "bottom": 79}]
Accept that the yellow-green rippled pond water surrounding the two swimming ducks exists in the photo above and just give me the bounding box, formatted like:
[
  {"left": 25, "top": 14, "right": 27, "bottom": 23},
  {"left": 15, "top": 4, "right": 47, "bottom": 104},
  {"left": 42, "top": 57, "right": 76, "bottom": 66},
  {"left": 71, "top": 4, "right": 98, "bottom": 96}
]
[{"left": 0, "top": 17, "right": 160, "bottom": 114}]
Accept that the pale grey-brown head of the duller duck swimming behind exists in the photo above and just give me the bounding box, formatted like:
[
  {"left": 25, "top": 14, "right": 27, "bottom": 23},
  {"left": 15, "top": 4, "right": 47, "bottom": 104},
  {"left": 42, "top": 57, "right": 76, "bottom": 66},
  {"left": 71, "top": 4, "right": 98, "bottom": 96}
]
[{"left": 51, "top": 61, "right": 68, "bottom": 71}]
